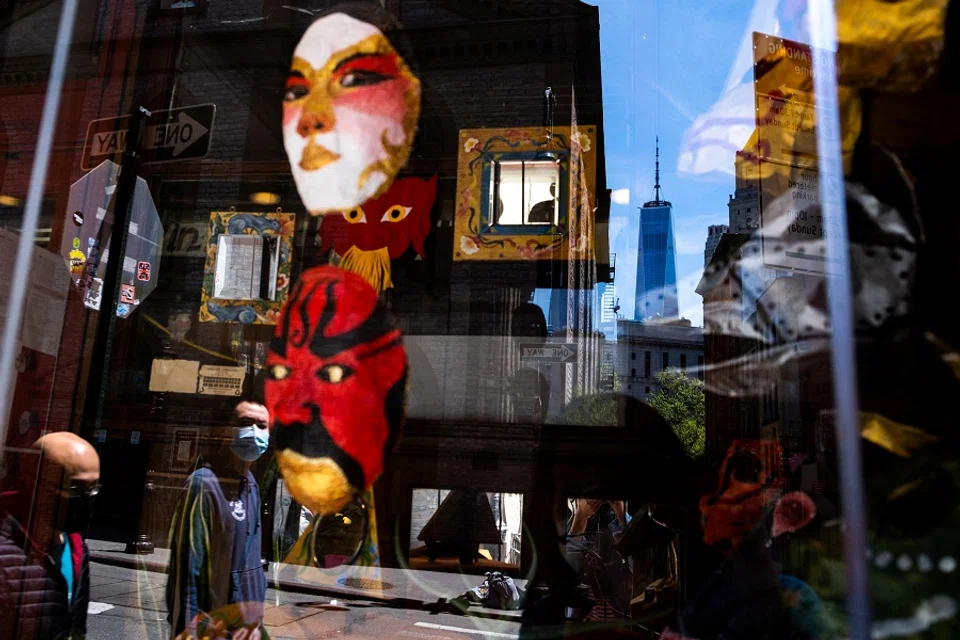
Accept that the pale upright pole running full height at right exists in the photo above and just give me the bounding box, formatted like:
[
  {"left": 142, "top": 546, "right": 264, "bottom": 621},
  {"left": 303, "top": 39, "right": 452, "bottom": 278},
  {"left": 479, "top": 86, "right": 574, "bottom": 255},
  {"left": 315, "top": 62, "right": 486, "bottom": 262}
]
[{"left": 809, "top": 0, "right": 871, "bottom": 640}]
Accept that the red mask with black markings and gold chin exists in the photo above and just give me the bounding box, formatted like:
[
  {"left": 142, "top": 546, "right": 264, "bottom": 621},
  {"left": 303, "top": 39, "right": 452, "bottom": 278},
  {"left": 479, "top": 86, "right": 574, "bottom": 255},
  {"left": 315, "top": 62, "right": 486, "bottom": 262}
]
[{"left": 265, "top": 266, "right": 407, "bottom": 515}]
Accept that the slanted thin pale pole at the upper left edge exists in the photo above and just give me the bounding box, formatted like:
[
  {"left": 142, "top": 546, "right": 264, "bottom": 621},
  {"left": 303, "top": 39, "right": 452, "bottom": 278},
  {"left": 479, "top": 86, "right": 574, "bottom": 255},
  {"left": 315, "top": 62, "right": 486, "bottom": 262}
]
[{"left": 0, "top": 0, "right": 78, "bottom": 454}]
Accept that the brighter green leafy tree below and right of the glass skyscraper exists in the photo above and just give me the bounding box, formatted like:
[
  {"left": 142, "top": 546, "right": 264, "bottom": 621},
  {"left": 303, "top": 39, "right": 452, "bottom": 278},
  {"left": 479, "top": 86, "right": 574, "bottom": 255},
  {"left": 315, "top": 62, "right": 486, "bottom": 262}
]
[{"left": 647, "top": 371, "right": 707, "bottom": 458}]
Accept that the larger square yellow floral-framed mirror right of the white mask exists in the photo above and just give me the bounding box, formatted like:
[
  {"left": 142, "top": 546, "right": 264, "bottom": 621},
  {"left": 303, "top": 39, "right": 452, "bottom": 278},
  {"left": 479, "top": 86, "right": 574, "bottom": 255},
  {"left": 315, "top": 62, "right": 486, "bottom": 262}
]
[{"left": 453, "top": 126, "right": 596, "bottom": 261}]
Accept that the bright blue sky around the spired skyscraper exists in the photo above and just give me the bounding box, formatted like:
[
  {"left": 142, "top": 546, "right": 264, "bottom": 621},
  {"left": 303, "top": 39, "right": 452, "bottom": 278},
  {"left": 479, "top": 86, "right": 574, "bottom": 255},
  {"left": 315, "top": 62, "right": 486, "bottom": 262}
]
[{"left": 587, "top": 0, "right": 787, "bottom": 325}]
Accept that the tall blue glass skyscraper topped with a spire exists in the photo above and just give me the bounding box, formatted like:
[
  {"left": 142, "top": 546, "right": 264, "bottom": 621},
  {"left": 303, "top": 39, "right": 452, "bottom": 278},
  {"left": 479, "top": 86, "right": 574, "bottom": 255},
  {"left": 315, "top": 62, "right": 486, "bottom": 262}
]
[{"left": 633, "top": 136, "right": 680, "bottom": 320}]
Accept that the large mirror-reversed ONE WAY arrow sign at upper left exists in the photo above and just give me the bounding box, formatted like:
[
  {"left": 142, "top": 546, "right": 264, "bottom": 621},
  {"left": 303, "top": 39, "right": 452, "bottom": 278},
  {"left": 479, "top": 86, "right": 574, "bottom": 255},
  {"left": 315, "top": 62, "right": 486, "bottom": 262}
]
[{"left": 82, "top": 104, "right": 217, "bottom": 169}]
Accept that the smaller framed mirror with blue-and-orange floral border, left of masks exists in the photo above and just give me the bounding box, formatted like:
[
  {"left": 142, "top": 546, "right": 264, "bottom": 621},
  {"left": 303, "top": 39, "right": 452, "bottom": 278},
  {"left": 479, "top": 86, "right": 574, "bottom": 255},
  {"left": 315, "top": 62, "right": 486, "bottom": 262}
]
[{"left": 200, "top": 210, "right": 296, "bottom": 324}]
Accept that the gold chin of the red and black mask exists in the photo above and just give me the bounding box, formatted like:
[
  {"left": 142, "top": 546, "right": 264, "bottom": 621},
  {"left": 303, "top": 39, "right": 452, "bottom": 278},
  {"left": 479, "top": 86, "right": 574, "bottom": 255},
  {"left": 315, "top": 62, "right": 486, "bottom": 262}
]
[{"left": 277, "top": 449, "right": 354, "bottom": 515}]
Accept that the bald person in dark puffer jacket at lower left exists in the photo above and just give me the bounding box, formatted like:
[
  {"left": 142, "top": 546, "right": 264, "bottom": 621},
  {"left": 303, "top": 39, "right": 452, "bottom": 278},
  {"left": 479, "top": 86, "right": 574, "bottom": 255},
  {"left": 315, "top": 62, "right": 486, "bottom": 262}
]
[{"left": 0, "top": 431, "right": 100, "bottom": 640}]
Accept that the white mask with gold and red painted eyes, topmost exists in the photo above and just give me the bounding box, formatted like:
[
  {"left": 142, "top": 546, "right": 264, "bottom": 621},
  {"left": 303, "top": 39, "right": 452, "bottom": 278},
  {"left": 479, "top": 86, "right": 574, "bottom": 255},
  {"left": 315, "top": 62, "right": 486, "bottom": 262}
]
[{"left": 283, "top": 13, "right": 420, "bottom": 215}]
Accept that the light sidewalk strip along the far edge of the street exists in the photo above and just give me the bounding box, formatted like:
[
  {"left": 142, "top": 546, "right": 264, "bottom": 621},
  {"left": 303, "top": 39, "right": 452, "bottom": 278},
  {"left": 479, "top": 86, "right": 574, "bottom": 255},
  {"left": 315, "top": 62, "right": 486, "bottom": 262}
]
[{"left": 87, "top": 540, "right": 526, "bottom": 622}]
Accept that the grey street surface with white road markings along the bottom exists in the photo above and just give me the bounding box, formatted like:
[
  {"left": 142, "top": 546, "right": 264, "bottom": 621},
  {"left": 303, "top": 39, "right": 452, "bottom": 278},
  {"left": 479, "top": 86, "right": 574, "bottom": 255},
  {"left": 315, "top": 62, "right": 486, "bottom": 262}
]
[{"left": 87, "top": 560, "right": 520, "bottom": 640}]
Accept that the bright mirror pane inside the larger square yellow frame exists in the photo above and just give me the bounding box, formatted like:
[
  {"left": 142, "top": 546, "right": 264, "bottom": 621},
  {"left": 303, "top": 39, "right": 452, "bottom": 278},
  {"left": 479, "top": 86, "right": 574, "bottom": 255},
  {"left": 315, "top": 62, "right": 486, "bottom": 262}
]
[{"left": 489, "top": 157, "right": 561, "bottom": 226}]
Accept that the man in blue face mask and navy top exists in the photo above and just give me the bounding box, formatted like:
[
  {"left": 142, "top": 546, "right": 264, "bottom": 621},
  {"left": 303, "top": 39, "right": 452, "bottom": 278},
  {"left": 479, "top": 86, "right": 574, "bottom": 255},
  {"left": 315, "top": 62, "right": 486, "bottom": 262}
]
[{"left": 167, "top": 402, "right": 270, "bottom": 639}]
